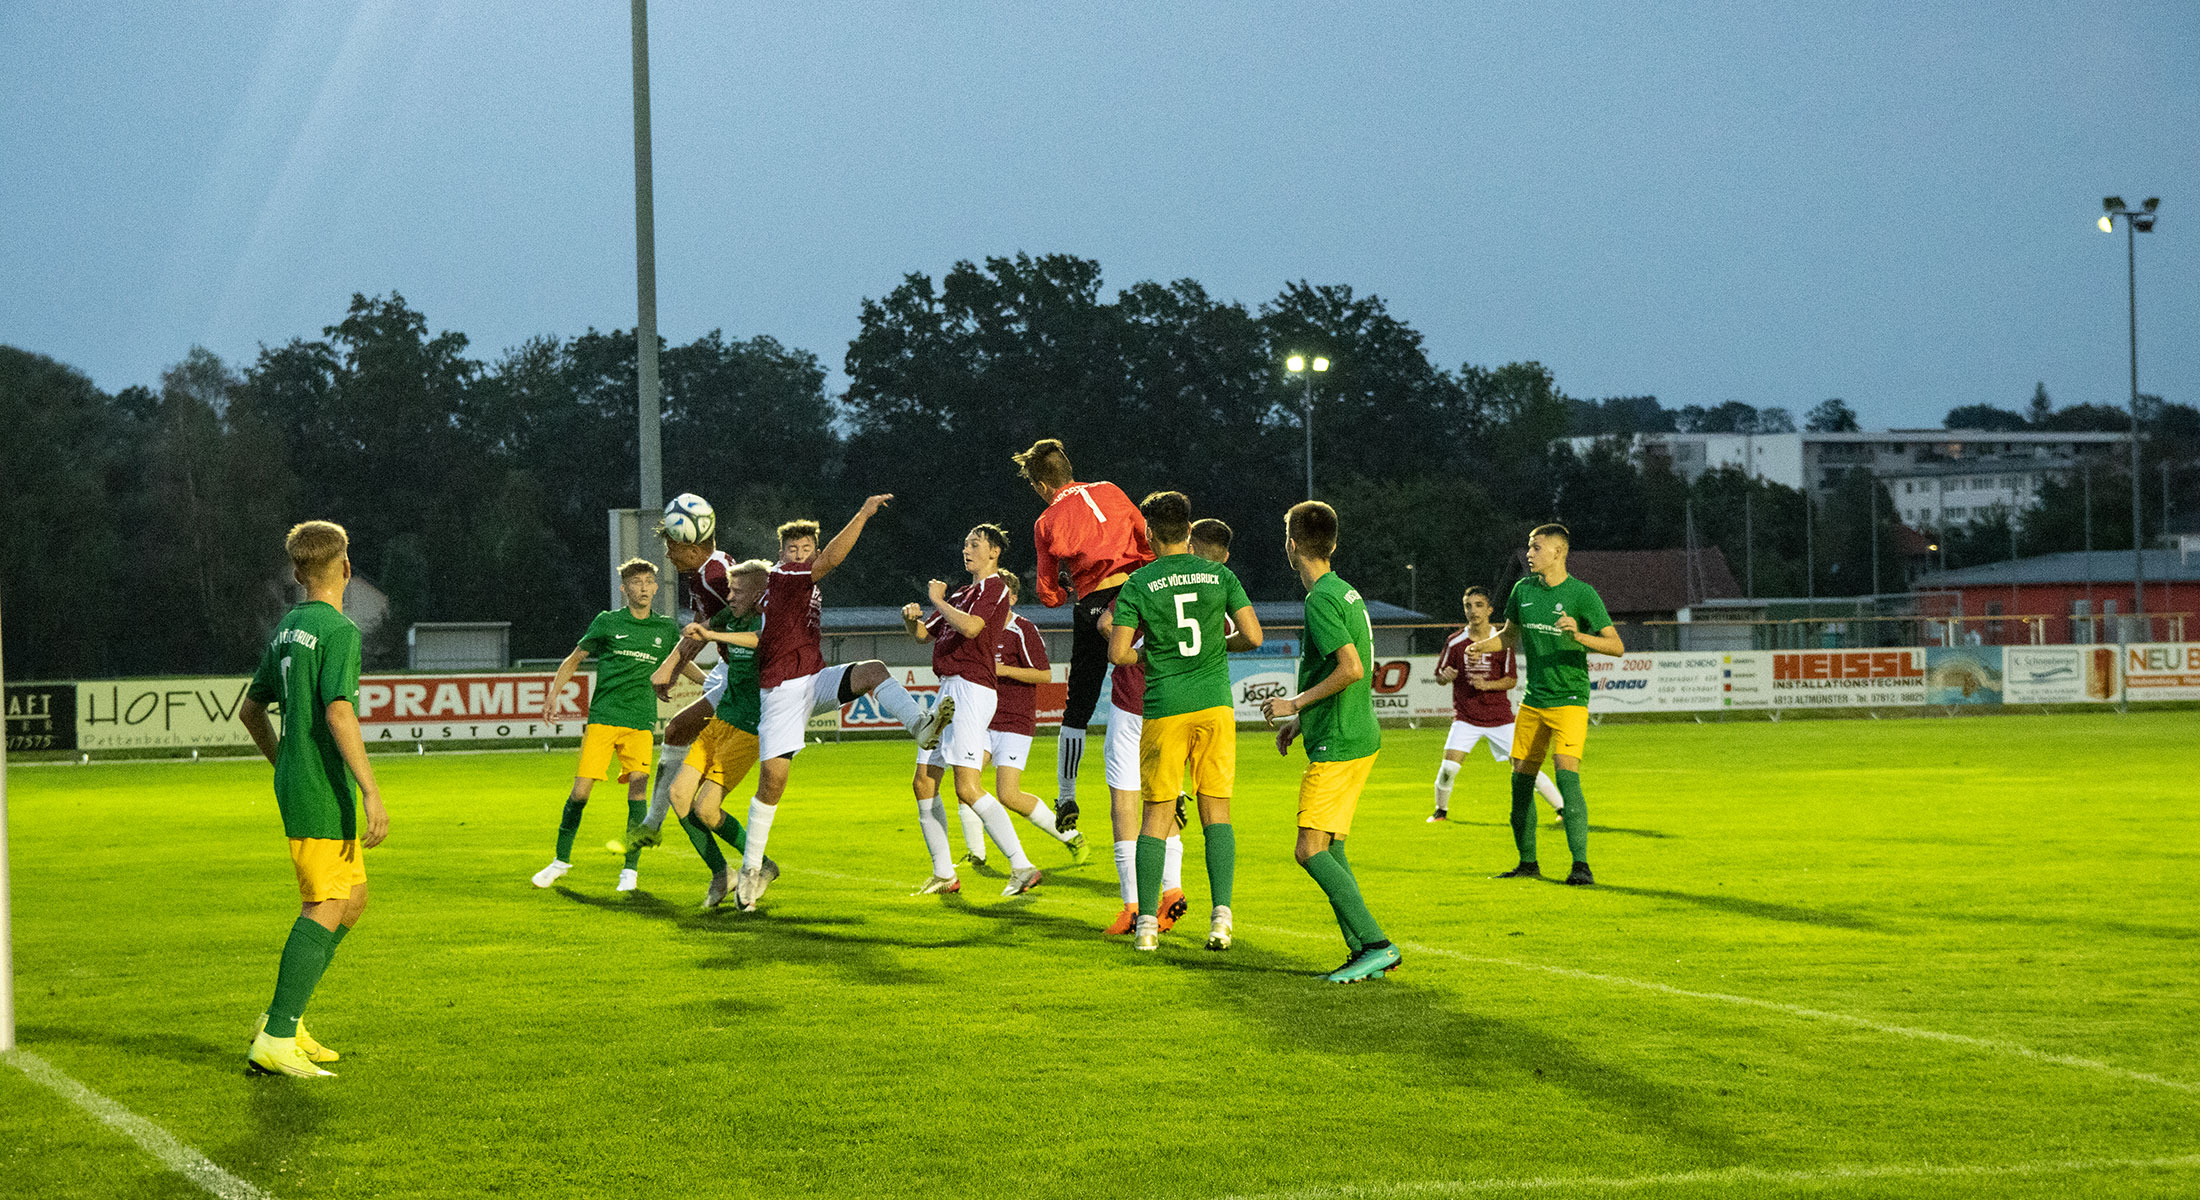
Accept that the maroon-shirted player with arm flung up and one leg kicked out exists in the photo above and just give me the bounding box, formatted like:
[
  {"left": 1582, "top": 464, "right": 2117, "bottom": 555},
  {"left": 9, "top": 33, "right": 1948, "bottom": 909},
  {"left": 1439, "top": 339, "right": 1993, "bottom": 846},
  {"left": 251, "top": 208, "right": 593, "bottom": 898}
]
[{"left": 733, "top": 495, "right": 955, "bottom": 909}]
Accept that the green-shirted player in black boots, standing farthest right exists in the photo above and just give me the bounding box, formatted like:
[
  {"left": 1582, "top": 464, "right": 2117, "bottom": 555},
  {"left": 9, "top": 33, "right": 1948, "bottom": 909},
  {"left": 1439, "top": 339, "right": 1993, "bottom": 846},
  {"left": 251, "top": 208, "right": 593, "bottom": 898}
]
[{"left": 1467, "top": 524, "right": 1628, "bottom": 887}]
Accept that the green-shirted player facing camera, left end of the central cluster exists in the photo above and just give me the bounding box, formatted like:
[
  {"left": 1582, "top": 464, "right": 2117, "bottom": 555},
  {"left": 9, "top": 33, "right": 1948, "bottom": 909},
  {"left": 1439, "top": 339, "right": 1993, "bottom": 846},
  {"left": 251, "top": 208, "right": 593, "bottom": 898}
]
[{"left": 535, "top": 559, "right": 702, "bottom": 892}]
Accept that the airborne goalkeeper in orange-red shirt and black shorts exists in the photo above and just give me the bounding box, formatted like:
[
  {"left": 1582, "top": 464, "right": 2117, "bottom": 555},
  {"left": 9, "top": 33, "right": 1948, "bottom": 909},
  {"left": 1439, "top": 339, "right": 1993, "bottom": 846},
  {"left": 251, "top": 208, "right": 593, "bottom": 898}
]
[{"left": 1014, "top": 438, "right": 1153, "bottom": 828}]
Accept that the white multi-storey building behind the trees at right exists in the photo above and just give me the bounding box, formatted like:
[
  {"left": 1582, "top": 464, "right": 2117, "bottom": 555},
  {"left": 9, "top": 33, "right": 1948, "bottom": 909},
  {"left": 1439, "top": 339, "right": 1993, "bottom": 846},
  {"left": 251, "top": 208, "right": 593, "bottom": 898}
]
[{"left": 1564, "top": 429, "right": 2130, "bottom": 528}]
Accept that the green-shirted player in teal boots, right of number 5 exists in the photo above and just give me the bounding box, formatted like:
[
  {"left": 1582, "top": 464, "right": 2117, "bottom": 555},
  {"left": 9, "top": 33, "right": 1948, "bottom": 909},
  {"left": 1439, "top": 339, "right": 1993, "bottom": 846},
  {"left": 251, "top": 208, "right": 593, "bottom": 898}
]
[{"left": 1261, "top": 500, "right": 1399, "bottom": 984}]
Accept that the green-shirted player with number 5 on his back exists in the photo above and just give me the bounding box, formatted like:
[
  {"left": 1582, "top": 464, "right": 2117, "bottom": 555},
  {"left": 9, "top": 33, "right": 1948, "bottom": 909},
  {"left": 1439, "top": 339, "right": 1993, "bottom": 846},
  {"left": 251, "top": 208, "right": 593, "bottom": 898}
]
[{"left": 1109, "top": 491, "right": 1261, "bottom": 951}]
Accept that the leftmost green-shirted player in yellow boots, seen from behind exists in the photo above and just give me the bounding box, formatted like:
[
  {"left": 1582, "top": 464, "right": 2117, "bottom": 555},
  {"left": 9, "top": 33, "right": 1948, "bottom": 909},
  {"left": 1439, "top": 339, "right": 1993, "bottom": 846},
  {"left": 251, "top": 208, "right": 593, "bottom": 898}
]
[{"left": 238, "top": 522, "right": 389, "bottom": 1074}]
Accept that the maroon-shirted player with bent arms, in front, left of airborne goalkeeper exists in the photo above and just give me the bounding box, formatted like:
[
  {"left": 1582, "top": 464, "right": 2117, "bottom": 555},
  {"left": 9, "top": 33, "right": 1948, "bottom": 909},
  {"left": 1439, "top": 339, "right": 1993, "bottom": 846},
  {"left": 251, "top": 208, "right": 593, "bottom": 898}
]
[{"left": 902, "top": 524, "right": 1045, "bottom": 896}]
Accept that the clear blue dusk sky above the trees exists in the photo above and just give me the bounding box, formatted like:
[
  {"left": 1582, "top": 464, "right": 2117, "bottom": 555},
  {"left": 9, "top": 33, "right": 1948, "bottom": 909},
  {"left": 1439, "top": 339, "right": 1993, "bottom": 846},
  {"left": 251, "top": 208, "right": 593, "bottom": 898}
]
[{"left": 0, "top": 0, "right": 2200, "bottom": 427}]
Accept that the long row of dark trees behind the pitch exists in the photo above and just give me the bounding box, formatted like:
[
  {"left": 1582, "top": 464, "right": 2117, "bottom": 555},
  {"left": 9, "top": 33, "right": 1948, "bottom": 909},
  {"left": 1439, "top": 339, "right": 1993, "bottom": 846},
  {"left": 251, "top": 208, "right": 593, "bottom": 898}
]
[{"left": 0, "top": 255, "right": 2200, "bottom": 678}]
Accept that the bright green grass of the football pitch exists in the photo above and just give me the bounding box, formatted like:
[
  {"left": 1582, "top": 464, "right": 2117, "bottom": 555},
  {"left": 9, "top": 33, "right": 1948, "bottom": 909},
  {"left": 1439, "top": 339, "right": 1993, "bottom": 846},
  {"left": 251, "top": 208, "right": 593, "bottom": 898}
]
[{"left": 0, "top": 713, "right": 2200, "bottom": 1200}]
